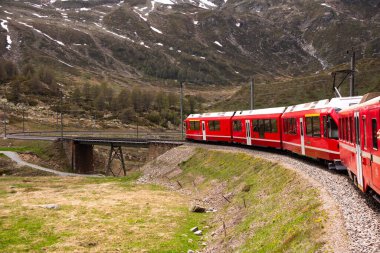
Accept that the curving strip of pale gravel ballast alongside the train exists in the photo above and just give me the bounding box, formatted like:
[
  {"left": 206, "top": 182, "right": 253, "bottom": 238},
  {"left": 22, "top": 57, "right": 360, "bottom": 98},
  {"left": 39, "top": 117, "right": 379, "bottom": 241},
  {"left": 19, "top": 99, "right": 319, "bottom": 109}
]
[{"left": 187, "top": 143, "right": 380, "bottom": 253}]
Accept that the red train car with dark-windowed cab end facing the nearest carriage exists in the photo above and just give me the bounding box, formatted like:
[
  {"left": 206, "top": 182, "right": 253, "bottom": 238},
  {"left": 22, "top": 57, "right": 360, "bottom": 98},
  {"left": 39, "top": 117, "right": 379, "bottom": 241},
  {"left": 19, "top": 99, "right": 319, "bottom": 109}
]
[{"left": 282, "top": 97, "right": 361, "bottom": 165}]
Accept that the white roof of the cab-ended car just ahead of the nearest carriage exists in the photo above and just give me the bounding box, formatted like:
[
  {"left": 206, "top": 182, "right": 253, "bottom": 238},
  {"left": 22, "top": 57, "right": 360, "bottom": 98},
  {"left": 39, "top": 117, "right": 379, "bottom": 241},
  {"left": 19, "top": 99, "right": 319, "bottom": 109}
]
[{"left": 285, "top": 96, "right": 362, "bottom": 113}]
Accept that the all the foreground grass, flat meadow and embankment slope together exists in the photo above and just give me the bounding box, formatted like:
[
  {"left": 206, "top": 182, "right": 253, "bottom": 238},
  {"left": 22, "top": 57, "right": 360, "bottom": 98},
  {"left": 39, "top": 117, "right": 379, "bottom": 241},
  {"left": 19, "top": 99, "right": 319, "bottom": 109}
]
[{"left": 0, "top": 148, "right": 328, "bottom": 252}]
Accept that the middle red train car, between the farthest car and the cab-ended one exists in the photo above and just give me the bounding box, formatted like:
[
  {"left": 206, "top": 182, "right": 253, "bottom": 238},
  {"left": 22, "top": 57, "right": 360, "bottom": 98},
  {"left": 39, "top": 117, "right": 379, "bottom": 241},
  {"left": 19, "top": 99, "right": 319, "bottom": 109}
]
[{"left": 232, "top": 107, "right": 286, "bottom": 149}]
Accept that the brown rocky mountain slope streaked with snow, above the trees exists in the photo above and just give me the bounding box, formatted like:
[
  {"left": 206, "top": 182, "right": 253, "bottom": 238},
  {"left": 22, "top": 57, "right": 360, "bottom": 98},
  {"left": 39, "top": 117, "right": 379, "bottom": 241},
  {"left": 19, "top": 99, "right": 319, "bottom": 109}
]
[{"left": 0, "top": 0, "right": 380, "bottom": 84}]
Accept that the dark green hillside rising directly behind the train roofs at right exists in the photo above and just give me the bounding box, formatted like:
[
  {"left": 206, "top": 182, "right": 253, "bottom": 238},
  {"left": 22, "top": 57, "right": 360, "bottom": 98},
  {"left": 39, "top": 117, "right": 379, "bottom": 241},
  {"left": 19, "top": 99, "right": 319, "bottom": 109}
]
[{"left": 212, "top": 58, "right": 380, "bottom": 111}]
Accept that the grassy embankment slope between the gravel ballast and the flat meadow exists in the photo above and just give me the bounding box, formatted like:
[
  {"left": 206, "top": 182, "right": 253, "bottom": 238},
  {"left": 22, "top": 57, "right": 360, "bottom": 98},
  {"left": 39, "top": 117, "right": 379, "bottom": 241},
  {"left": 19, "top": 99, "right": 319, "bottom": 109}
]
[{"left": 178, "top": 150, "right": 325, "bottom": 252}]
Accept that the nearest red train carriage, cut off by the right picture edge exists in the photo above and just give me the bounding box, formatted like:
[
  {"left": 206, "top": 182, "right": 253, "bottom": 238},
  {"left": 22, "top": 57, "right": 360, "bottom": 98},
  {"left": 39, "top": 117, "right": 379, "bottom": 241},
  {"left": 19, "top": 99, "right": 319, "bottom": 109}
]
[{"left": 339, "top": 94, "right": 380, "bottom": 194}]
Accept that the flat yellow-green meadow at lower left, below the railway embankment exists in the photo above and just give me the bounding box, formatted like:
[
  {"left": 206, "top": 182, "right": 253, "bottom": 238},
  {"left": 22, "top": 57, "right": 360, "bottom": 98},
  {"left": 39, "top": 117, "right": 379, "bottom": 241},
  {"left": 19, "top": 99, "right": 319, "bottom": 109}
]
[{"left": 0, "top": 175, "right": 207, "bottom": 252}]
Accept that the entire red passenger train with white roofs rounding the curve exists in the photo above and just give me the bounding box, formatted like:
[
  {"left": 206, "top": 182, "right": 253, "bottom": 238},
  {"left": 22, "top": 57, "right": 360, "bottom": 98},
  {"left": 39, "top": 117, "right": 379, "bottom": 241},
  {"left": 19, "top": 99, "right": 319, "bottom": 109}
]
[{"left": 185, "top": 94, "right": 380, "bottom": 198}]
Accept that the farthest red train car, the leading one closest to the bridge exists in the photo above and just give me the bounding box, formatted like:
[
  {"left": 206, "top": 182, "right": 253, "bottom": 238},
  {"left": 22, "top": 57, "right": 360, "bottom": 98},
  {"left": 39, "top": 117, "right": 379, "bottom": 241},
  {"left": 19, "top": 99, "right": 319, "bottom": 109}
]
[{"left": 185, "top": 112, "right": 235, "bottom": 142}]
